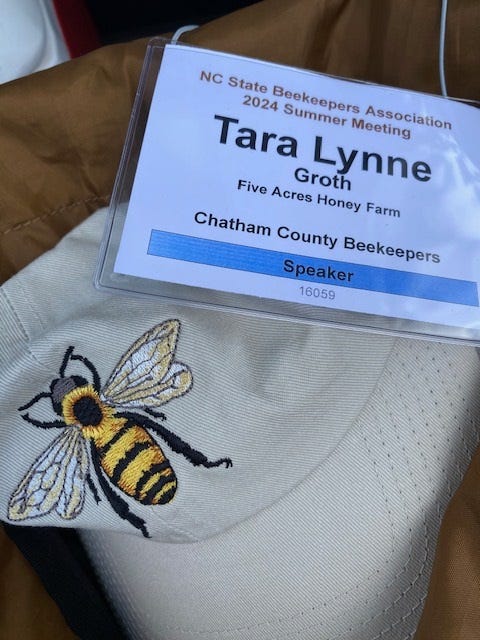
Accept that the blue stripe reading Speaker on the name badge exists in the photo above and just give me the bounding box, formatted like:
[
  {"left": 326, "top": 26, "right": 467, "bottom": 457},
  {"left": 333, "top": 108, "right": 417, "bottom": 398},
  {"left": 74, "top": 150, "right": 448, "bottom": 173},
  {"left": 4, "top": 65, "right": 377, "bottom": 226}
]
[{"left": 148, "top": 229, "right": 478, "bottom": 307}]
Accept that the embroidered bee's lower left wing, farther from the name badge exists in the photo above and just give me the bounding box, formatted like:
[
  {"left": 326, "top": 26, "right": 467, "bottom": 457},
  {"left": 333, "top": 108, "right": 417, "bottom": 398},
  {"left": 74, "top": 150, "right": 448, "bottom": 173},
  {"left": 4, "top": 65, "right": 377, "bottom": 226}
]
[{"left": 8, "top": 427, "right": 88, "bottom": 520}]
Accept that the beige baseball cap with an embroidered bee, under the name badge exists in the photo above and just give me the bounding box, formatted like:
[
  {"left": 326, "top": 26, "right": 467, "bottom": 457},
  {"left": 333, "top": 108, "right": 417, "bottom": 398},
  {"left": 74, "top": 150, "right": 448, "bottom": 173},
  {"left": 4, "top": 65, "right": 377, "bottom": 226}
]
[{"left": 0, "top": 211, "right": 480, "bottom": 640}]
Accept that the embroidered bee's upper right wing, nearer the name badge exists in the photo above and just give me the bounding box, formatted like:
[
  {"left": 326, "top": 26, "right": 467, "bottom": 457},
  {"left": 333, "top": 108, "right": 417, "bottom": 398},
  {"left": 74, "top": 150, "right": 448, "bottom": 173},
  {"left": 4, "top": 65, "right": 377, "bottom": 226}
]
[{"left": 101, "top": 320, "right": 192, "bottom": 407}]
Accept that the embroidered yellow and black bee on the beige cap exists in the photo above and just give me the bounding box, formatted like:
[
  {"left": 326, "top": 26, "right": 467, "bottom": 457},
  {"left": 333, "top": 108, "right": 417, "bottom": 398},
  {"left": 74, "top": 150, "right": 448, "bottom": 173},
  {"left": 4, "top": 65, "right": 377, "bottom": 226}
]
[{"left": 8, "top": 320, "right": 232, "bottom": 537}]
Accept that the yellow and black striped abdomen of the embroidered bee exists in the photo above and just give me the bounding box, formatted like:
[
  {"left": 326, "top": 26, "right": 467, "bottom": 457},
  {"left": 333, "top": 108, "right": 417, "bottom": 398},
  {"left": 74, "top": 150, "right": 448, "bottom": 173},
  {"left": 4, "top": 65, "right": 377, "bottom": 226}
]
[{"left": 97, "top": 424, "right": 177, "bottom": 505}]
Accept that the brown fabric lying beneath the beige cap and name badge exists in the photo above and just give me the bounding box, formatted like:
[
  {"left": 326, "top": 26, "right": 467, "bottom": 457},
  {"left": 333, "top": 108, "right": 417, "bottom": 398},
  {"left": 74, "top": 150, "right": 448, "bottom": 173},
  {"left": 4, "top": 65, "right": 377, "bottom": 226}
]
[{"left": 0, "top": 0, "right": 480, "bottom": 640}]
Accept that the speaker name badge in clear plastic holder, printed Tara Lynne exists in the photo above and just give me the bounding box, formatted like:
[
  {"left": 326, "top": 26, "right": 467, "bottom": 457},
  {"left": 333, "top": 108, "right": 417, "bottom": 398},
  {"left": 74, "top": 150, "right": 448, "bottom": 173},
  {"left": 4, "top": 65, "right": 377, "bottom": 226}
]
[{"left": 96, "top": 40, "right": 480, "bottom": 342}]
